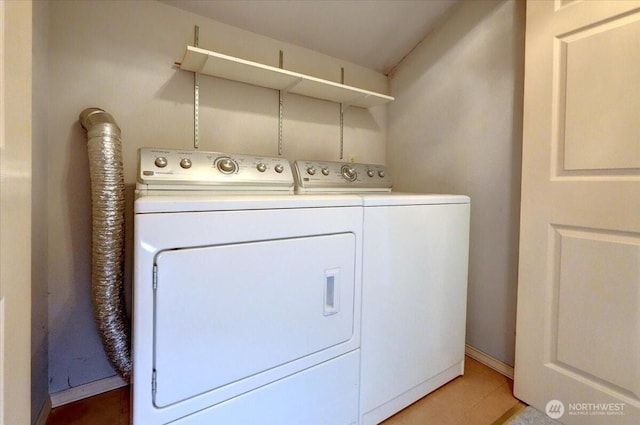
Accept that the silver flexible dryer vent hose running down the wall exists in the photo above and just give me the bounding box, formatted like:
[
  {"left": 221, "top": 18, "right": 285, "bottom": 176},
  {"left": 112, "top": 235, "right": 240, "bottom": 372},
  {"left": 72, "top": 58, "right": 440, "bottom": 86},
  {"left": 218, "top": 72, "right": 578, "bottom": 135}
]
[{"left": 80, "top": 108, "right": 131, "bottom": 382}]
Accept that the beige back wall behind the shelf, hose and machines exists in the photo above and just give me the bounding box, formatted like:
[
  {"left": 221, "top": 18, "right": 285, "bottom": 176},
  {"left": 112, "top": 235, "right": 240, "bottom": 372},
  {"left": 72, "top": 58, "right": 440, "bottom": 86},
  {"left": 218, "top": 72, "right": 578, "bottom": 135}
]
[{"left": 47, "top": 0, "right": 387, "bottom": 392}]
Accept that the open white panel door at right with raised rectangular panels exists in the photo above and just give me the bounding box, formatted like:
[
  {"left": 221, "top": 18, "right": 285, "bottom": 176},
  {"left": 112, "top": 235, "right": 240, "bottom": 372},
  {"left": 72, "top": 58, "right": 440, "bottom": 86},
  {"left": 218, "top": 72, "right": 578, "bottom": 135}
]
[{"left": 514, "top": 0, "right": 640, "bottom": 425}]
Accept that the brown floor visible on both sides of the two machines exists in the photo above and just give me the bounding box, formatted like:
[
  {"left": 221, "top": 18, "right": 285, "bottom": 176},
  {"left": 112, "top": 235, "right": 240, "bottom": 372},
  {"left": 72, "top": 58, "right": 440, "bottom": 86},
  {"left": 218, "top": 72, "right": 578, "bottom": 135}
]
[{"left": 47, "top": 357, "right": 523, "bottom": 425}]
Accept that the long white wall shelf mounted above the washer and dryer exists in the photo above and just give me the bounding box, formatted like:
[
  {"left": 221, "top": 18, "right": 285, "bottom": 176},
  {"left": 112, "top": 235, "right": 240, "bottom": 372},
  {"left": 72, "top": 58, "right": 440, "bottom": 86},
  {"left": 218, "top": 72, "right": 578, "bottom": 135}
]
[{"left": 179, "top": 46, "right": 394, "bottom": 108}]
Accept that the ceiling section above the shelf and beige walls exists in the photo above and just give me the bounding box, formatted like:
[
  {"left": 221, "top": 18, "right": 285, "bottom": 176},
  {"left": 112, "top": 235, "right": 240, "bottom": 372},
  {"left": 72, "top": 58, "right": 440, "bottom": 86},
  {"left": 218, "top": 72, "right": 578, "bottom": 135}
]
[{"left": 161, "top": 0, "right": 462, "bottom": 74}]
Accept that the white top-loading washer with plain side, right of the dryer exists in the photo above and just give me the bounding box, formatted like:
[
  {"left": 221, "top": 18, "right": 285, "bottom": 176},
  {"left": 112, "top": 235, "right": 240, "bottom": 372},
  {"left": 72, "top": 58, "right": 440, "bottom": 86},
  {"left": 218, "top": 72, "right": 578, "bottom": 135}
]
[{"left": 294, "top": 161, "right": 470, "bottom": 425}]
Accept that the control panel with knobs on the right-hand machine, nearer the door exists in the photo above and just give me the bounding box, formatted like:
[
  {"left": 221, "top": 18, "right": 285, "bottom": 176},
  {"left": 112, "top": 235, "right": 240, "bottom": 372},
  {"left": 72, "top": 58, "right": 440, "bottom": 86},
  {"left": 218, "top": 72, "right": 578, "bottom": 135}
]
[{"left": 293, "top": 160, "right": 392, "bottom": 192}]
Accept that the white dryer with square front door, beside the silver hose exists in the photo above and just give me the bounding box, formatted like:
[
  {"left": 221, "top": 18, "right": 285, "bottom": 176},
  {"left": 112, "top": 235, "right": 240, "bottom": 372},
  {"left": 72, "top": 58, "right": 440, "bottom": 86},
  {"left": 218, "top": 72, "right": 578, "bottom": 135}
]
[{"left": 132, "top": 149, "right": 362, "bottom": 425}]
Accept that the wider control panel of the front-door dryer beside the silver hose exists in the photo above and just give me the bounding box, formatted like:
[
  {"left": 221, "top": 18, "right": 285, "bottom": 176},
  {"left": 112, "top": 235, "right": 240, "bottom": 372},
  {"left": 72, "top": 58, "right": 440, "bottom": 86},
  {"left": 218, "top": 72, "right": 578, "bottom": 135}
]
[{"left": 138, "top": 148, "right": 294, "bottom": 191}]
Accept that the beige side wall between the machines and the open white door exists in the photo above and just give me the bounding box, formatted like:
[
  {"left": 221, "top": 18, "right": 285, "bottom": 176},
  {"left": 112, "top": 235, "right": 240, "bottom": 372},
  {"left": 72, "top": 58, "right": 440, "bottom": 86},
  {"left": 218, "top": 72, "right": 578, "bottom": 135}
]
[{"left": 387, "top": 0, "right": 524, "bottom": 365}]
